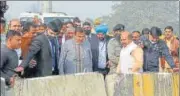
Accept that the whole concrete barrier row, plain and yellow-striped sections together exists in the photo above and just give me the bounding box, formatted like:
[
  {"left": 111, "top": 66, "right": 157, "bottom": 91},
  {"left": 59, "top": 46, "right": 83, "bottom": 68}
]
[{"left": 9, "top": 73, "right": 180, "bottom": 96}]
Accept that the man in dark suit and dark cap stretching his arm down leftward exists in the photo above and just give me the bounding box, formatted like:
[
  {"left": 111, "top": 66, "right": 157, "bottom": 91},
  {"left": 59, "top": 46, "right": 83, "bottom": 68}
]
[{"left": 16, "top": 20, "right": 62, "bottom": 77}]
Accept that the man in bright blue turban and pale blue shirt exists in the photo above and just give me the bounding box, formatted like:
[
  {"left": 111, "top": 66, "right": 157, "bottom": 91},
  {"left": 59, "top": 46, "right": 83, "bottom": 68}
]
[{"left": 95, "top": 24, "right": 110, "bottom": 75}]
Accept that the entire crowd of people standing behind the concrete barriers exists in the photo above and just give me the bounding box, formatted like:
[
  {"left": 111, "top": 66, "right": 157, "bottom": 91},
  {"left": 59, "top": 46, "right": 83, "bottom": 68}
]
[{"left": 0, "top": 15, "right": 180, "bottom": 86}]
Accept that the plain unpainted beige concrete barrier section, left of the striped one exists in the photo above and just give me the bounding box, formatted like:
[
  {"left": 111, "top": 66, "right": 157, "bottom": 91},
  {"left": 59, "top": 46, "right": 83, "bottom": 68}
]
[{"left": 14, "top": 73, "right": 107, "bottom": 96}]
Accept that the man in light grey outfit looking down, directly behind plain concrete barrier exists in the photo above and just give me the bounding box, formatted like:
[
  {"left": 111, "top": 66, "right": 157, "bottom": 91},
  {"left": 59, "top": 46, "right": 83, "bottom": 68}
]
[{"left": 59, "top": 27, "right": 92, "bottom": 74}]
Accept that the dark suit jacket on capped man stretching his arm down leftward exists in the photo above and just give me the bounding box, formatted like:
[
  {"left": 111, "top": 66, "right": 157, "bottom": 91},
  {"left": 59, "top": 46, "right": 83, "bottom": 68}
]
[{"left": 21, "top": 33, "right": 59, "bottom": 77}]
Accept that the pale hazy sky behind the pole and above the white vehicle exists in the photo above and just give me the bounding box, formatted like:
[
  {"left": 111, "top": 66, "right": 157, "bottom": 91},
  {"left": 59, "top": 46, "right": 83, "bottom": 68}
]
[{"left": 5, "top": 1, "right": 113, "bottom": 20}]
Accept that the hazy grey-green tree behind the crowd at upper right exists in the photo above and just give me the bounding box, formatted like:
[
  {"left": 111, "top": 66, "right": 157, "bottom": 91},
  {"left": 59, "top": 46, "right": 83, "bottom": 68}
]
[{"left": 102, "top": 1, "right": 179, "bottom": 33}]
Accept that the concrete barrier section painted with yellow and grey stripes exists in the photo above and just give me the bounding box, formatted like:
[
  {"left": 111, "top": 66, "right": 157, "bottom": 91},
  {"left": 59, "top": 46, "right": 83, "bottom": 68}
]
[{"left": 105, "top": 73, "right": 180, "bottom": 96}]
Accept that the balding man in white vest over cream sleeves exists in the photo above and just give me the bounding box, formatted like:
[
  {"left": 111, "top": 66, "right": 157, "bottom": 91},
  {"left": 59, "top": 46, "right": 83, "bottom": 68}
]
[{"left": 116, "top": 31, "right": 143, "bottom": 73}]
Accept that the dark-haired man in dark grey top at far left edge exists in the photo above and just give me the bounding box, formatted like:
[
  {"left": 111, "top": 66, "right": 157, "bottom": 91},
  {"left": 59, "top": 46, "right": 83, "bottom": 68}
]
[{"left": 0, "top": 32, "right": 21, "bottom": 86}]
